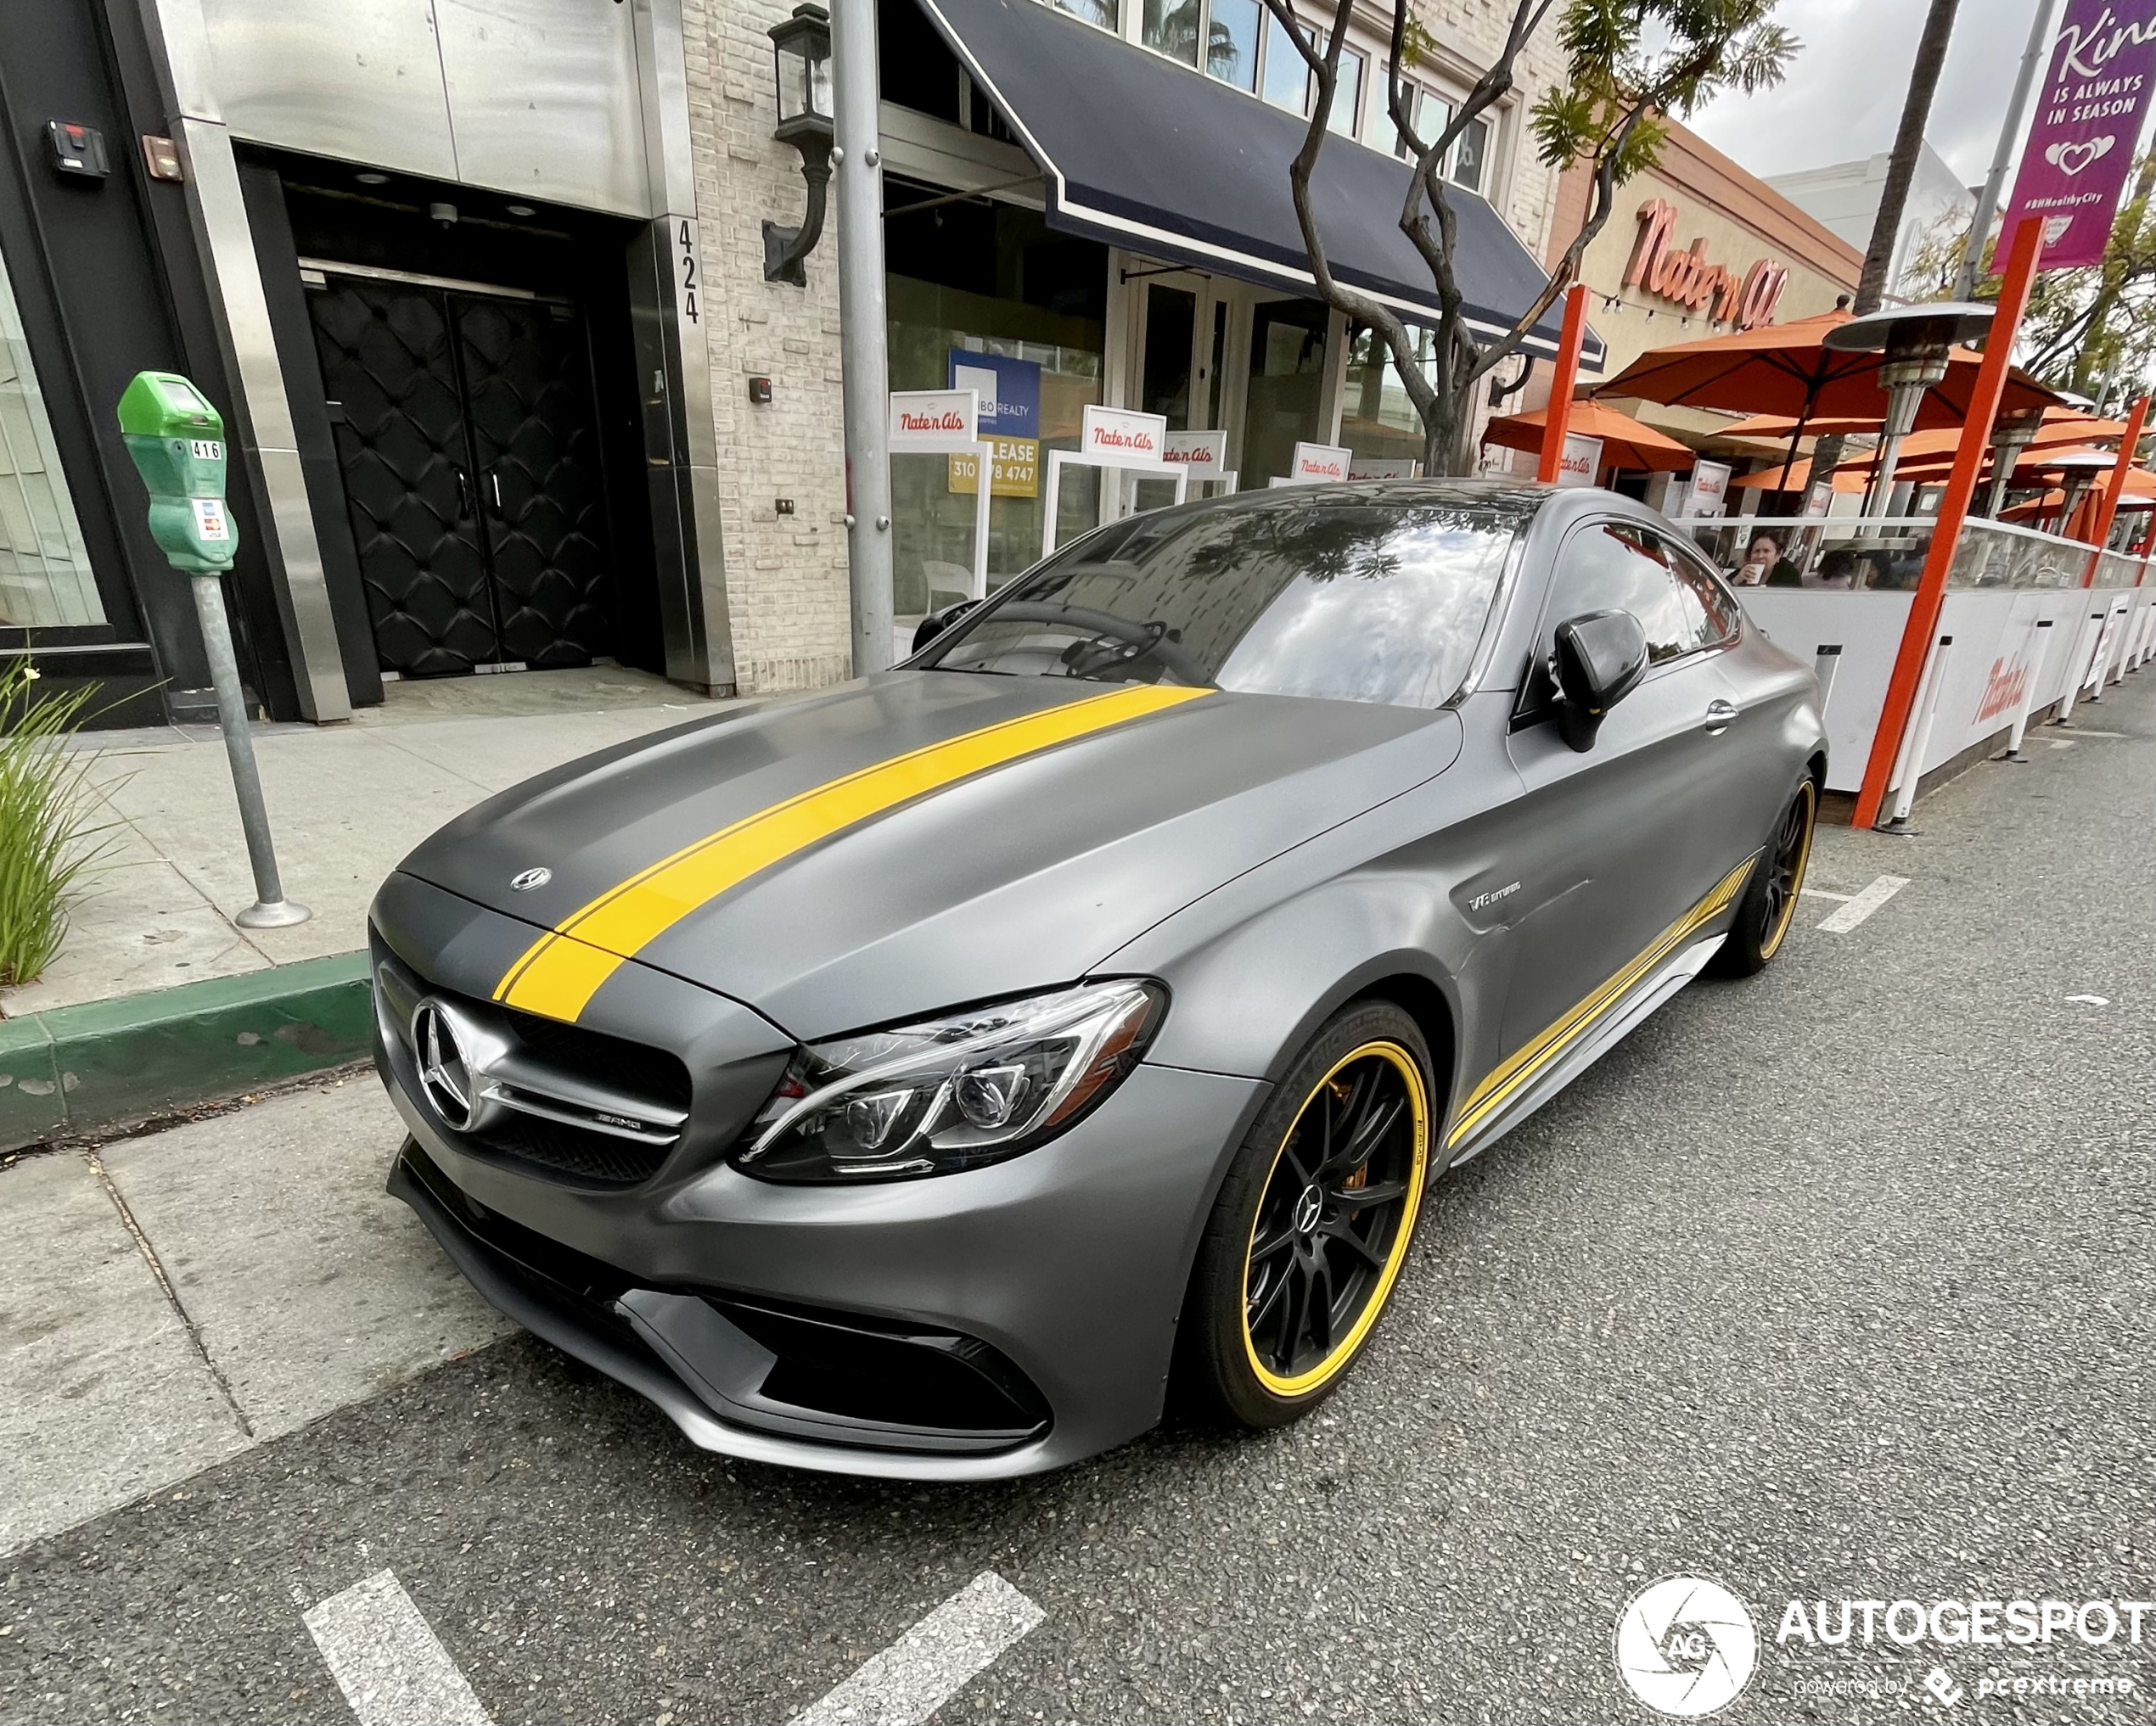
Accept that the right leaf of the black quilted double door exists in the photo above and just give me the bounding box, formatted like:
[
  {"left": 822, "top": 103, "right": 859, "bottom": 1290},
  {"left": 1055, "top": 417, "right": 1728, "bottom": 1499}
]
[{"left": 451, "top": 293, "right": 615, "bottom": 668}]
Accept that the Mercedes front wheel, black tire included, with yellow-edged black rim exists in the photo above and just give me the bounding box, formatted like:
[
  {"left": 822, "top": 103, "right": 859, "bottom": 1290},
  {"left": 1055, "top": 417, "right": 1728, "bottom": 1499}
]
[{"left": 1177, "top": 1002, "right": 1438, "bottom": 1426}]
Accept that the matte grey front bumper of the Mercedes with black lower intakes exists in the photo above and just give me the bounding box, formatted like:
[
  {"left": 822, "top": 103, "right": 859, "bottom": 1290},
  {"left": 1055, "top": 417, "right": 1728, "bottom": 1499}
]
[{"left": 375, "top": 883, "right": 1263, "bottom": 1481}]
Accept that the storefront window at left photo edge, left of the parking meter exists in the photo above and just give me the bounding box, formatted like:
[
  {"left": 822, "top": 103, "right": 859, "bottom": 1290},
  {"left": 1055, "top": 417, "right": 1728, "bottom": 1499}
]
[{"left": 0, "top": 245, "right": 105, "bottom": 629}]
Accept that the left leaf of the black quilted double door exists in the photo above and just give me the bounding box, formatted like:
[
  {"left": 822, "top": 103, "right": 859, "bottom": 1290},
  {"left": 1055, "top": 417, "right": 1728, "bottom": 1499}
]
[{"left": 308, "top": 278, "right": 507, "bottom": 676}]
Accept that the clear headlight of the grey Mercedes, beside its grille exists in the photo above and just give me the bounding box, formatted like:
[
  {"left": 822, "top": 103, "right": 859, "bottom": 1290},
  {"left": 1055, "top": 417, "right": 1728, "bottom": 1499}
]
[{"left": 733, "top": 980, "right": 1166, "bottom": 1181}]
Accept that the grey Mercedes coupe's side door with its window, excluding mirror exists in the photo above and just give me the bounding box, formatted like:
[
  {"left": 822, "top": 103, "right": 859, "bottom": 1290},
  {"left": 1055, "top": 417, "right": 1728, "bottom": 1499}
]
[{"left": 1502, "top": 517, "right": 1733, "bottom": 1056}]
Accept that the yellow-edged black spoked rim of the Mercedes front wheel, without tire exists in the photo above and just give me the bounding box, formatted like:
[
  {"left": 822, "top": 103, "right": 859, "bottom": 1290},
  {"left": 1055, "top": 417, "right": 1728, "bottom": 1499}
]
[{"left": 1242, "top": 1039, "right": 1429, "bottom": 1396}]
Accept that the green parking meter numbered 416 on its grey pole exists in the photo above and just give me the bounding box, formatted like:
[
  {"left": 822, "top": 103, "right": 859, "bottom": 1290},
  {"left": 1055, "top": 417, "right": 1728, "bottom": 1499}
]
[{"left": 119, "top": 371, "right": 311, "bottom": 928}]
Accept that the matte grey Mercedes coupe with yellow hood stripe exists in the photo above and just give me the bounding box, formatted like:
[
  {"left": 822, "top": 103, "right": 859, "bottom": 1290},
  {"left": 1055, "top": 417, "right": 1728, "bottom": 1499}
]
[{"left": 373, "top": 480, "right": 1826, "bottom": 1478}]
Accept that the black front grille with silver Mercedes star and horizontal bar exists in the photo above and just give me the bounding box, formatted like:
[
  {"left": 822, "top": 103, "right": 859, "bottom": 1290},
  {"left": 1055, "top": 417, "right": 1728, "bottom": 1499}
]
[{"left": 375, "top": 948, "right": 692, "bottom": 1187}]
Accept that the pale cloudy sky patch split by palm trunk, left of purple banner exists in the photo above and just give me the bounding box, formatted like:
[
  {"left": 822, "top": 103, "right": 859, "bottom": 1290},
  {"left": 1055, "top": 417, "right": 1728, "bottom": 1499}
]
[{"left": 1690, "top": 0, "right": 2059, "bottom": 185}]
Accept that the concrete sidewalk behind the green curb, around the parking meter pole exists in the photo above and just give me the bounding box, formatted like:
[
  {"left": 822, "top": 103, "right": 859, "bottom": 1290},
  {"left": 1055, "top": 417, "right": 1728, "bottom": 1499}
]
[{"left": 0, "top": 666, "right": 729, "bottom": 1019}]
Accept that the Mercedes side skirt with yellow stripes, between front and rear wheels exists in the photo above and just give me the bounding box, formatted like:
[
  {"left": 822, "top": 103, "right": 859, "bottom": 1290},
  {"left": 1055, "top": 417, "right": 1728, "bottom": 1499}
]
[{"left": 1445, "top": 855, "right": 1757, "bottom": 1163}]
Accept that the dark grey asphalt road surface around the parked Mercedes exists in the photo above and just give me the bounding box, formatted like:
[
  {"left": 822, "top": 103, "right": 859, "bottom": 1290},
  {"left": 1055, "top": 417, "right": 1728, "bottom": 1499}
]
[{"left": 0, "top": 675, "right": 2156, "bottom": 1726}]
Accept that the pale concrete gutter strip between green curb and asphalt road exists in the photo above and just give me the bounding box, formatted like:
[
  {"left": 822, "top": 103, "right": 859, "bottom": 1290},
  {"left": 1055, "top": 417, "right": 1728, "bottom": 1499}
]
[{"left": 0, "top": 1073, "right": 511, "bottom": 1555}]
